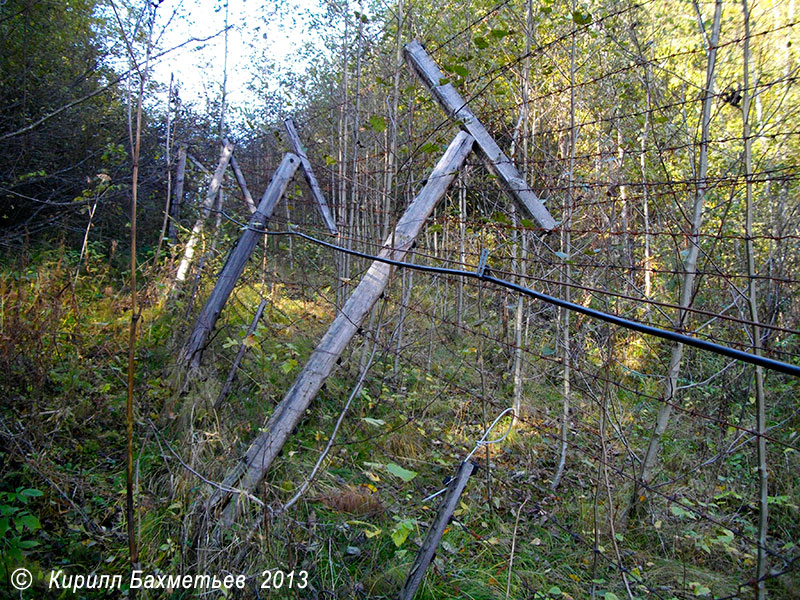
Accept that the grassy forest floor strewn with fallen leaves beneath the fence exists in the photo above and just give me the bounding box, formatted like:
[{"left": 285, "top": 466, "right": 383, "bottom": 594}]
[{"left": 0, "top": 248, "right": 800, "bottom": 600}]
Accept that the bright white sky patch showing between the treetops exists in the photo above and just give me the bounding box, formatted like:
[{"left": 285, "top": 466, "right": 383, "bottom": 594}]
[{"left": 153, "top": 0, "right": 322, "bottom": 118}]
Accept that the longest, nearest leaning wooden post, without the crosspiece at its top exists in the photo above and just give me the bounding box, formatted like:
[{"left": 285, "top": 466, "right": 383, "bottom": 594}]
[{"left": 208, "top": 132, "right": 474, "bottom": 527}]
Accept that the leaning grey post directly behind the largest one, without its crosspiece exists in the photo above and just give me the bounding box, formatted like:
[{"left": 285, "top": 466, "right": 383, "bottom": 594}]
[{"left": 180, "top": 152, "right": 300, "bottom": 367}]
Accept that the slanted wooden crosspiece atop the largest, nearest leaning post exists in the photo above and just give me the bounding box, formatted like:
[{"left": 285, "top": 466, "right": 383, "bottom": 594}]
[{"left": 403, "top": 40, "right": 556, "bottom": 230}]
